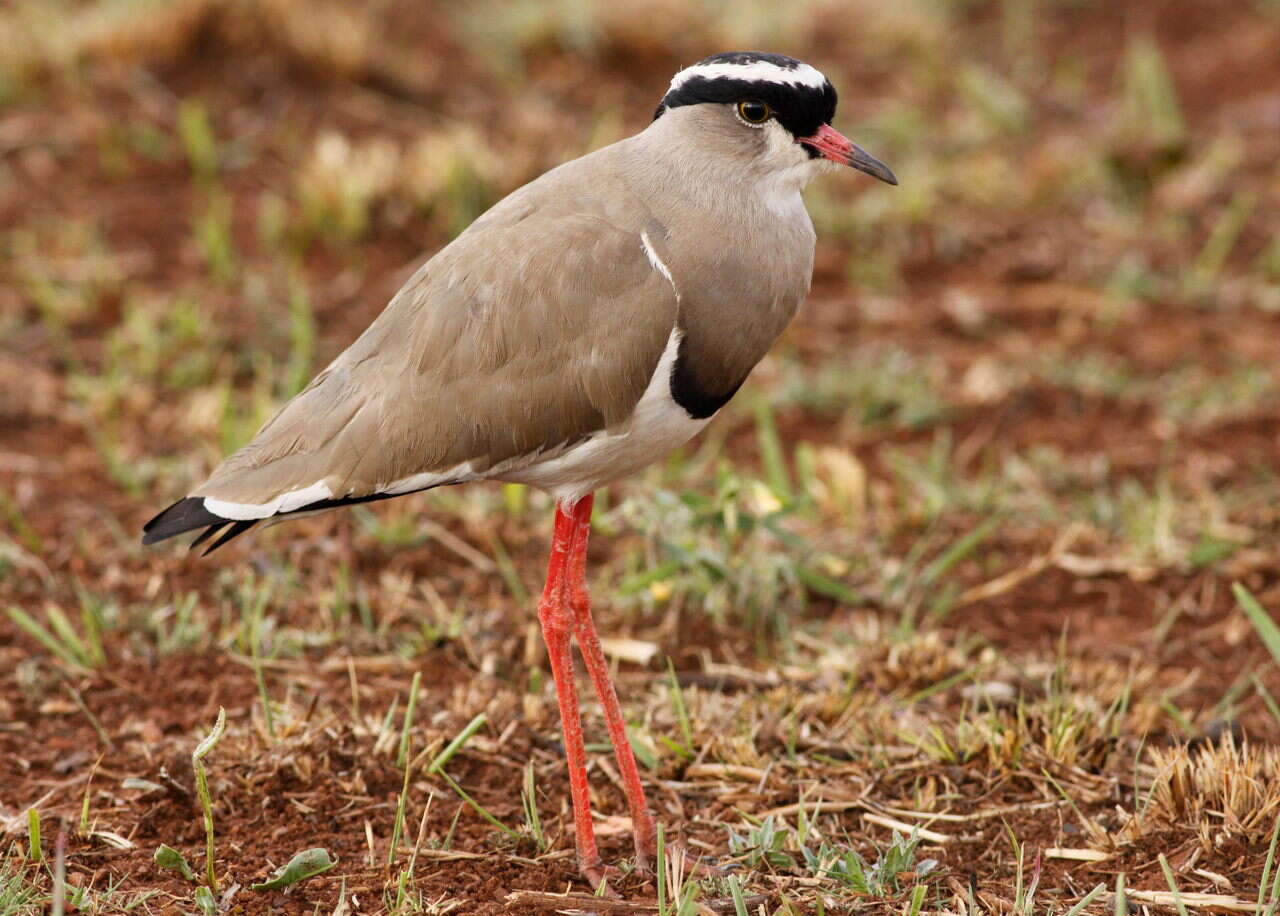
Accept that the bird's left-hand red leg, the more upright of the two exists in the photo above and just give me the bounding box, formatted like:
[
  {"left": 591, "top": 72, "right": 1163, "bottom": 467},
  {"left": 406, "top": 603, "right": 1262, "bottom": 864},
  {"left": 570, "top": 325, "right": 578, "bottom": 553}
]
[{"left": 538, "top": 505, "right": 604, "bottom": 888}]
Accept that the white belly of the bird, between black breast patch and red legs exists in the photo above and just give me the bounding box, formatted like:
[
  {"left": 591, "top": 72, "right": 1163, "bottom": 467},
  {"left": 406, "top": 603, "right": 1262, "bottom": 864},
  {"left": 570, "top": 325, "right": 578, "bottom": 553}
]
[{"left": 495, "top": 330, "right": 710, "bottom": 503}]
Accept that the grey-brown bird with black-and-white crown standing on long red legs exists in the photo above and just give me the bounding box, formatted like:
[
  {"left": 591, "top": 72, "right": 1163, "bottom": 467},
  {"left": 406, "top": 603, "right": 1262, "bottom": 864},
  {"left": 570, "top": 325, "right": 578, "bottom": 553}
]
[{"left": 142, "top": 51, "right": 897, "bottom": 888}]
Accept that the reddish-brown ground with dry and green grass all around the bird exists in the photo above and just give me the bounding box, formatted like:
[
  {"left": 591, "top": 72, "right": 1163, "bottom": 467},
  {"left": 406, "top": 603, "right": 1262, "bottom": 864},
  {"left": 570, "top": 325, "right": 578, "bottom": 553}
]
[{"left": 0, "top": 0, "right": 1280, "bottom": 916}]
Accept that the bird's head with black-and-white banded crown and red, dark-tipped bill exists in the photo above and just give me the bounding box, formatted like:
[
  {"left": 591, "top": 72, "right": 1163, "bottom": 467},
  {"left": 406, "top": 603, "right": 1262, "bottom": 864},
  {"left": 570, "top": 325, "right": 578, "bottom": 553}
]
[{"left": 654, "top": 51, "right": 897, "bottom": 190}]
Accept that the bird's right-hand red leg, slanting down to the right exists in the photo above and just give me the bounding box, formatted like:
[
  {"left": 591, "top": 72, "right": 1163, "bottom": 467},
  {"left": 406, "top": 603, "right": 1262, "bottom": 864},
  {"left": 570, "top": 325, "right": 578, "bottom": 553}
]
[{"left": 566, "top": 494, "right": 658, "bottom": 874}]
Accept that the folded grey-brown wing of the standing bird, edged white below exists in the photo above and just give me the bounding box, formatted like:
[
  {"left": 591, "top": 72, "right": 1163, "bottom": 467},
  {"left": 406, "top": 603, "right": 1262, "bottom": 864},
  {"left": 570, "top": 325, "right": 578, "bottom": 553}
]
[{"left": 179, "top": 210, "right": 676, "bottom": 518}]
